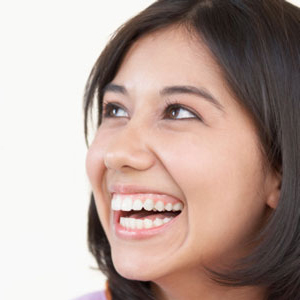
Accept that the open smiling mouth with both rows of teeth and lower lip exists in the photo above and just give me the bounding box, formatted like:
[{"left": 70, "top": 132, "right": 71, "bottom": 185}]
[{"left": 111, "top": 194, "right": 183, "bottom": 238}]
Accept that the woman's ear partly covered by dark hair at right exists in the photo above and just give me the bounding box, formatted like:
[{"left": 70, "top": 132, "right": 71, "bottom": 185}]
[{"left": 265, "top": 171, "right": 282, "bottom": 209}]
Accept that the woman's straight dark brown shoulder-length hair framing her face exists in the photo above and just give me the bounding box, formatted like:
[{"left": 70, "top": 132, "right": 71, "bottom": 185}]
[{"left": 84, "top": 0, "right": 300, "bottom": 300}]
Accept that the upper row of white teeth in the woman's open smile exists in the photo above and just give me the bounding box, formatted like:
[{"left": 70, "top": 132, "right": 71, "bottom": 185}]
[{"left": 111, "top": 194, "right": 183, "bottom": 211}]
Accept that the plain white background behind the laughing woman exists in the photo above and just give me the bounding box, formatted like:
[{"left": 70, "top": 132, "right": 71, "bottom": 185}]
[{"left": 0, "top": 0, "right": 300, "bottom": 300}]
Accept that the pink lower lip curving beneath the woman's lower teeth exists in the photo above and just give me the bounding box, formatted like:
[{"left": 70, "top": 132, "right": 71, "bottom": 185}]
[{"left": 113, "top": 211, "right": 182, "bottom": 239}]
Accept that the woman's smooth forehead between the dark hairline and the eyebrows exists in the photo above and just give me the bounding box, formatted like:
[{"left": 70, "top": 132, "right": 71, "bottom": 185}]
[{"left": 106, "top": 26, "right": 237, "bottom": 116}]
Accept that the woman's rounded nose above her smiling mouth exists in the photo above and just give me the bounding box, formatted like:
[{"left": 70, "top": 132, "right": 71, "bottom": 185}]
[{"left": 104, "top": 123, "right": 155, "bottom": 171}]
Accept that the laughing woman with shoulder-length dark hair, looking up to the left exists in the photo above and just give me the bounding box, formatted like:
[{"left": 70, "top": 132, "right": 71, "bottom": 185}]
[{"left": 77, "top": 0, "right": 300, "bottom": 300}]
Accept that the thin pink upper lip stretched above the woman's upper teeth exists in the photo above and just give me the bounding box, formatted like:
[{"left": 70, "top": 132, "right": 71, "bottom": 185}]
[{"left": 108, "top": 184, "right": 181, "bottom": 201}]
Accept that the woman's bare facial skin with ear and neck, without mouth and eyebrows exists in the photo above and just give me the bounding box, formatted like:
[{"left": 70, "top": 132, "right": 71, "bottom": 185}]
[{"left": 86, "top": 27, "right": 280, "bottom": 300}]
